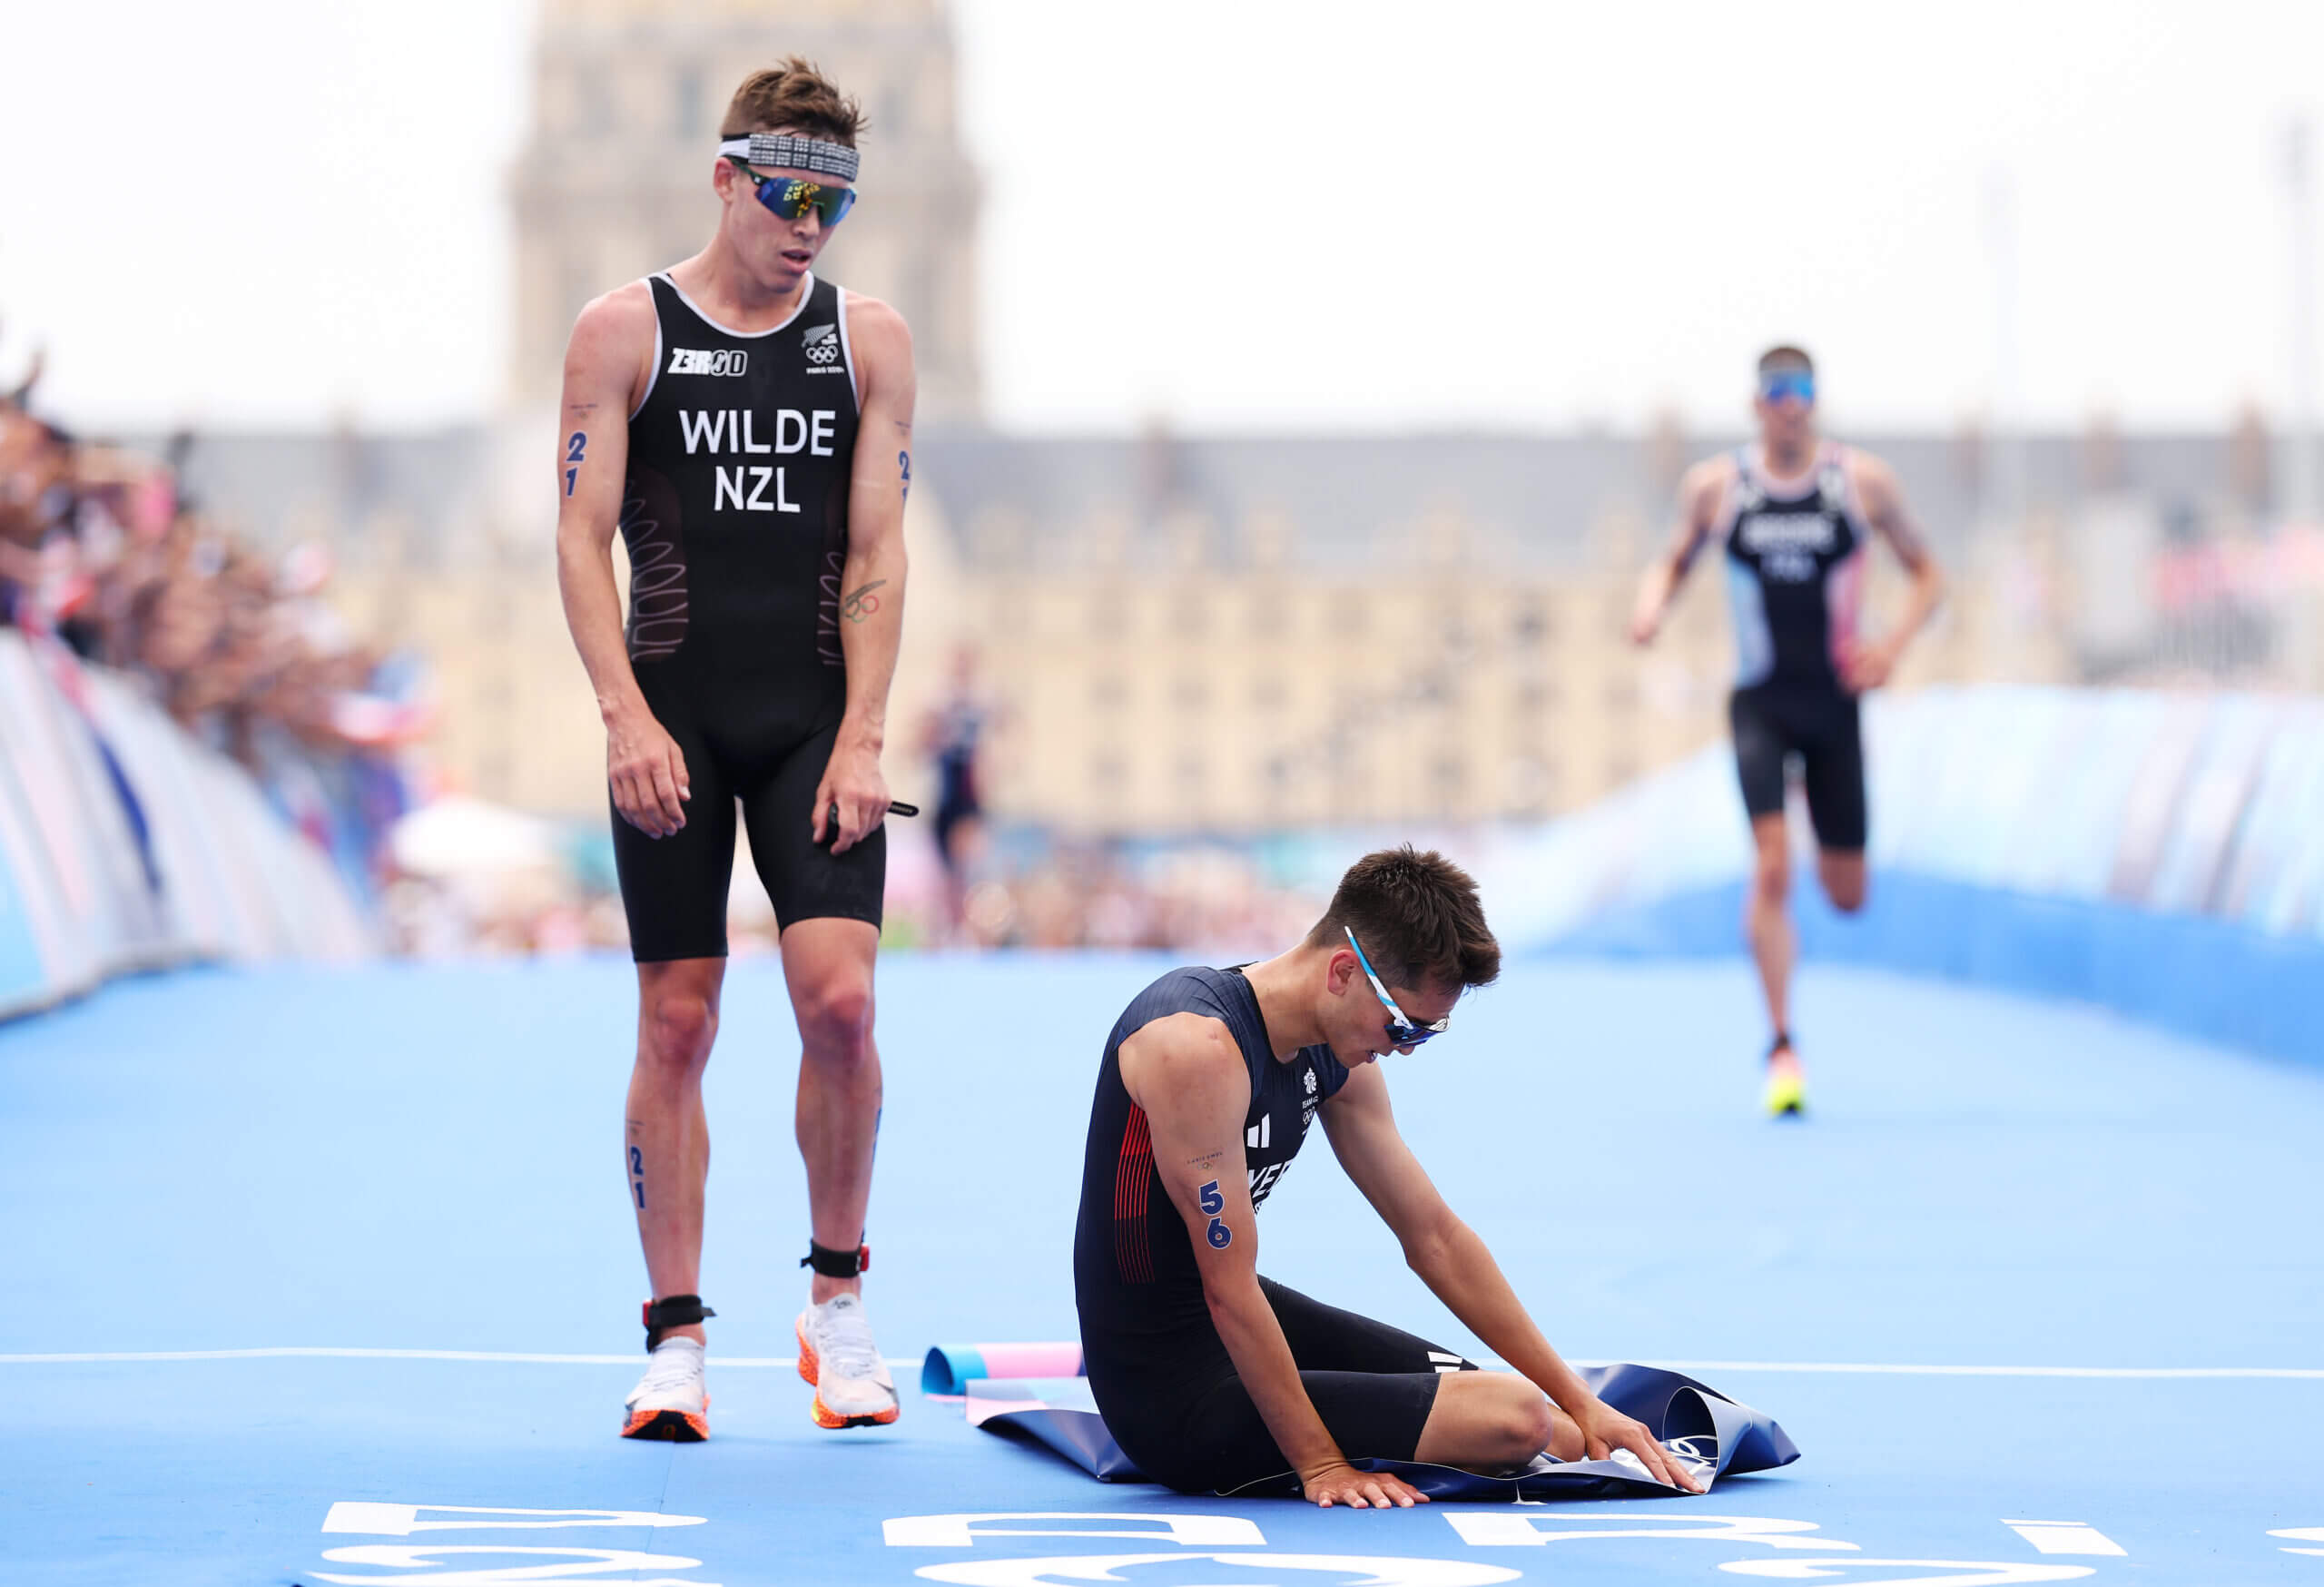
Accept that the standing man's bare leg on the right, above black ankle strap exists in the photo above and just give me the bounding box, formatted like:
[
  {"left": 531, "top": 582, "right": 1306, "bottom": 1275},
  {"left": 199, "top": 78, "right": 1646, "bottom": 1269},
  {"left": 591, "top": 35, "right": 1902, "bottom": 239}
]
[{"left": 783, "top": 920, "right": 881, "bottom": 1306}]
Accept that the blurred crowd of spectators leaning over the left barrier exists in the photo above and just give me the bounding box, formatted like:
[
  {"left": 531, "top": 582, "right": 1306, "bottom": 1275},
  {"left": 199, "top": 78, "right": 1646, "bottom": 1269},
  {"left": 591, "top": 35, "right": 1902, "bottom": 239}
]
[{"left": 0, "top": 341, "right": 430, "bottom": 892}]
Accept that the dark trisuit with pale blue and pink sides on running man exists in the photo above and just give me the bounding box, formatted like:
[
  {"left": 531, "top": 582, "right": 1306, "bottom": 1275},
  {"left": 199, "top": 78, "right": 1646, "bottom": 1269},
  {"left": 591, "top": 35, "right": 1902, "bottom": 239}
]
[{"left": 1718, "top": 444, "right": 1871, "bottom": 848}]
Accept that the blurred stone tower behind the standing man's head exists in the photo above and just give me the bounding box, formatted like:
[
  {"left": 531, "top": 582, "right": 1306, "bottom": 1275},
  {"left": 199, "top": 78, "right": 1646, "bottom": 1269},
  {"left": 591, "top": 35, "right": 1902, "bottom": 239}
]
[{"left": 509, "top": 0, "right": 980, "bottom": 423}]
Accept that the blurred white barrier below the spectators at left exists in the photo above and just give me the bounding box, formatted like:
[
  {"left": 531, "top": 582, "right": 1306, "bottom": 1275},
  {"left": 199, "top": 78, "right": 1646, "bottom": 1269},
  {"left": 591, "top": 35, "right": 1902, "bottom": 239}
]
[{"left": 0, "top": 630, "right": 377, "bottom": 1015}]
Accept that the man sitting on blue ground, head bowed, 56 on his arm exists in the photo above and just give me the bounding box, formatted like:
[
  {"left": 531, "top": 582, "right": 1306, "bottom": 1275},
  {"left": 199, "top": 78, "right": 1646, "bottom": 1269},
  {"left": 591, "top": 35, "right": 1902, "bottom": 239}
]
[{"left": 1074, "top": 848, "right": 1701, "bottom": 1508}]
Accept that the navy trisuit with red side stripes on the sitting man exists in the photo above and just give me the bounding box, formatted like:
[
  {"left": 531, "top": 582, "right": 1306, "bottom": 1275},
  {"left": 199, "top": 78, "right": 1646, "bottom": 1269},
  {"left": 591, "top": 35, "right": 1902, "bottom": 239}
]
[{"left": 1074, "top": 969, "right": 1469, "bottom": 1492}]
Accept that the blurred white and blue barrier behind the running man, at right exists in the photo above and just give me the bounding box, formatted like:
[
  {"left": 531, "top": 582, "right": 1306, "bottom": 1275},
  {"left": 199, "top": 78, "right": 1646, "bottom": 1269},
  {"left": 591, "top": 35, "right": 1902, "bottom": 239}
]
[{"left": 1485, "top": 688, "right": 2324, "bottom": 1062}]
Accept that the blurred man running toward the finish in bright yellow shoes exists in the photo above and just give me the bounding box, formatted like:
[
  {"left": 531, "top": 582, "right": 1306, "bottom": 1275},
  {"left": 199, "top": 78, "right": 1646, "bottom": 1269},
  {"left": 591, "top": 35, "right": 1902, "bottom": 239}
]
[{"left": 1630, "top": 346, "right": 1943, "bottom": 1115}]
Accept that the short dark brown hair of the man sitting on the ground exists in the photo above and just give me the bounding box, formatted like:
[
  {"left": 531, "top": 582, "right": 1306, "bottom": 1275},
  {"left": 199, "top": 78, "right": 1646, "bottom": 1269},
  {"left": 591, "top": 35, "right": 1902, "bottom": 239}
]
[{"left": 1306, "top": 843, "right": 1502, "bottom": 988}]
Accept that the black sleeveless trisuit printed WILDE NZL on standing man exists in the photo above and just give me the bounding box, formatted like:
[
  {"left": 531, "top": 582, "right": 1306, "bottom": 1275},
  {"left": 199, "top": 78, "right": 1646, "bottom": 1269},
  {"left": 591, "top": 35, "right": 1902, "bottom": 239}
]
[{"left": 614, "top": 274, "right": 888, "bottom": 962}]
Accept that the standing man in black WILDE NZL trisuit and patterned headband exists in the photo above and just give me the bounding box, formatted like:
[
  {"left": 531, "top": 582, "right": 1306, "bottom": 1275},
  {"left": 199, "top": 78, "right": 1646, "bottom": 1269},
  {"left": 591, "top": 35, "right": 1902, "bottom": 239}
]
[{"left": 557, "top": 58, "right": 913, "bottom": 1441}]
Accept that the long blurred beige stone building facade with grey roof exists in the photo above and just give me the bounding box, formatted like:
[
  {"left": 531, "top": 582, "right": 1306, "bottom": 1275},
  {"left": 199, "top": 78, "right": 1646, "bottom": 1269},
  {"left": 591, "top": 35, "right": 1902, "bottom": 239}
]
[{"left": 267, "top": 429, "right": 2073, "bottom": 834}]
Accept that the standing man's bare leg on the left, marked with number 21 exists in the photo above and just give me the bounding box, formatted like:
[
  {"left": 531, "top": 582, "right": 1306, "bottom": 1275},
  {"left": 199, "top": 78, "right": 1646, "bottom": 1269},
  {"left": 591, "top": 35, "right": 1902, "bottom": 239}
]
[{"left": 623, "top": 960, "right": 725, "bottom": 1338}]
